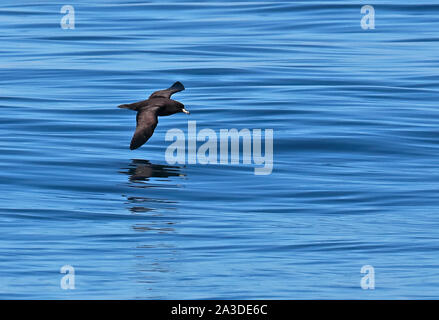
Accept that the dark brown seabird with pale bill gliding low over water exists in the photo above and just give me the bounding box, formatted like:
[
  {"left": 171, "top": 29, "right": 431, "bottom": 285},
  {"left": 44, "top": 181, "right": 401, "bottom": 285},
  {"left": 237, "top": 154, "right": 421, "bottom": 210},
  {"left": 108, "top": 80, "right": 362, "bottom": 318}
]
[{"left": 119, "top": 81, "right": 189, "bottom": 150}]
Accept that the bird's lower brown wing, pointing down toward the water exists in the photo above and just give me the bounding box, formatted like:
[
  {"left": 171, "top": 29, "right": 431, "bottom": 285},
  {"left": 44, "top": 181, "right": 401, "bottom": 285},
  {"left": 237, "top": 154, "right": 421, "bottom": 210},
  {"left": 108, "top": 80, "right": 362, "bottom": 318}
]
[{"left": 130, "top": 108, "right": 158, "bottom": 150}]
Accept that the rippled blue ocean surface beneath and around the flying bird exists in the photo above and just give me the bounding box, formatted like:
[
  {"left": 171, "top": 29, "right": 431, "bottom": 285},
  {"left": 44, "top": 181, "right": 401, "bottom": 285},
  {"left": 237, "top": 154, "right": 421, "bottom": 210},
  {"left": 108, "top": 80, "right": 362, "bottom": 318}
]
[{"left": 0, "top": 0, "right": 439, "bottom": 299}]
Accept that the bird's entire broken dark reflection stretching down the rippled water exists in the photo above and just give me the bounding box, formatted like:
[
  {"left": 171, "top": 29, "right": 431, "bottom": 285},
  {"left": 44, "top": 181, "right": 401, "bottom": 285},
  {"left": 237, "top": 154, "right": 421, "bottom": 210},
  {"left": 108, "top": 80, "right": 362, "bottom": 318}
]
[{"left": 119, "top": 159, "right": 185, "bottom": 290}]
